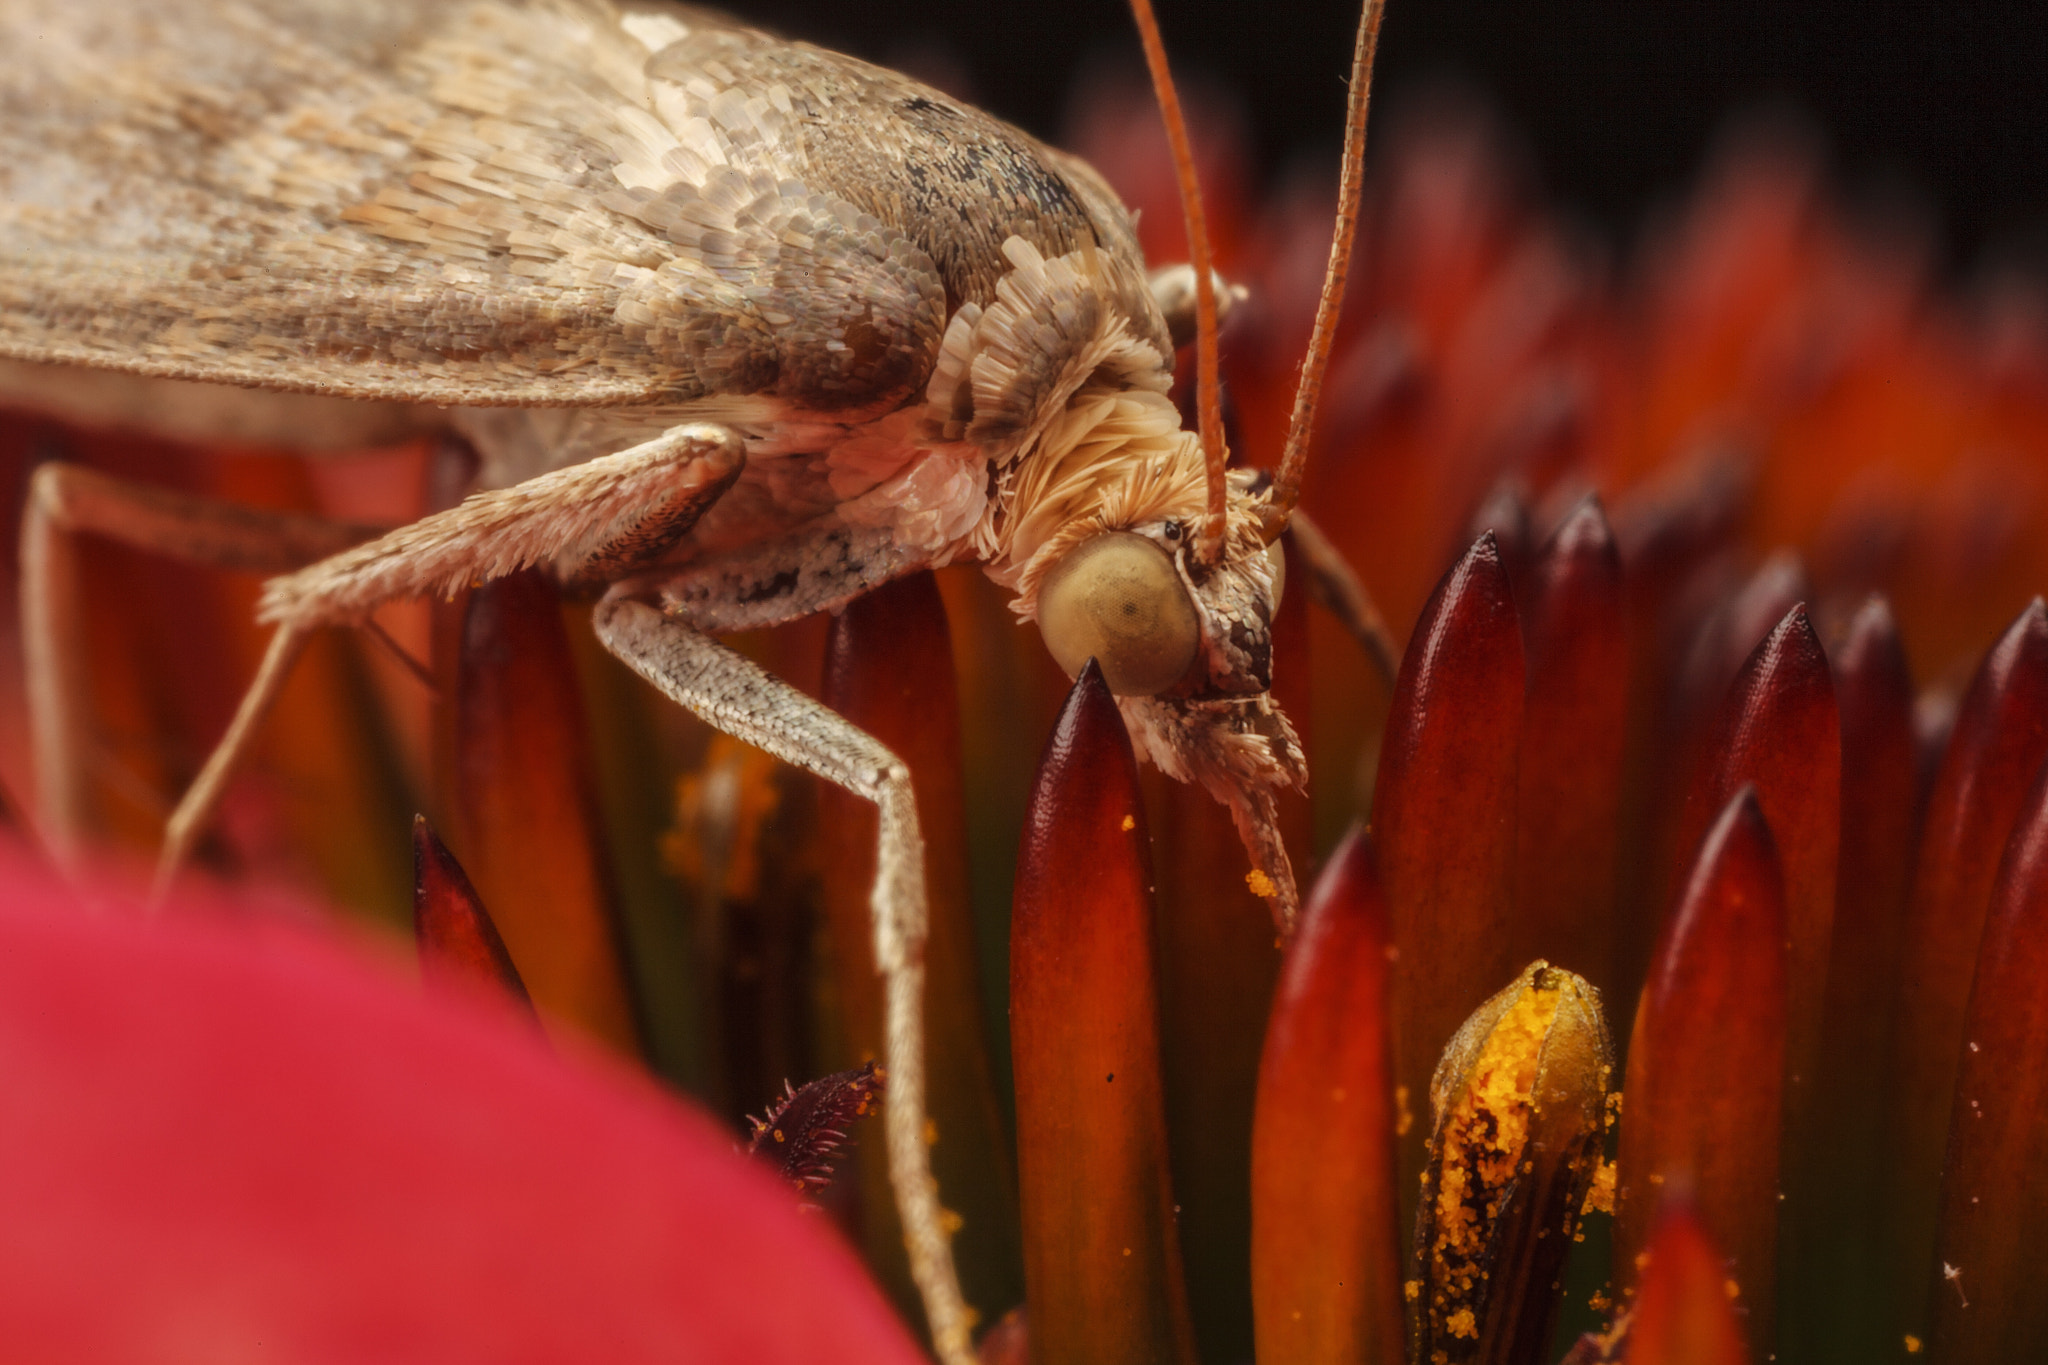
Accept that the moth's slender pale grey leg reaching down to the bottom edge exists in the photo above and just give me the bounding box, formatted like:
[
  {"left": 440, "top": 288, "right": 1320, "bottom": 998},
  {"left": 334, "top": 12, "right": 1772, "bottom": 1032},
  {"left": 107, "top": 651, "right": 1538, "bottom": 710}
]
[{"left": 594, "top": 598, "right": 975, "bottom": 1365}]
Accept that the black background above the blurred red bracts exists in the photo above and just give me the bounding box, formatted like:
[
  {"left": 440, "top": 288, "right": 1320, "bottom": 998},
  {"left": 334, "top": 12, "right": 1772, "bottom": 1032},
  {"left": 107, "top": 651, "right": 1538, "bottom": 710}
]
[{"left": 731, "top": 0, "right": 2048, "bottom": 272}]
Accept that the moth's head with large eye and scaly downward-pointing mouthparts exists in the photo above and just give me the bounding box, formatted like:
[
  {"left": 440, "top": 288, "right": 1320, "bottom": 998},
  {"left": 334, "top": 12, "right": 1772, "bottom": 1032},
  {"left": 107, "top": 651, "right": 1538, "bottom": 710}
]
[{"left": 1030, "top": 475, "right": 1307, "bottom": 923}]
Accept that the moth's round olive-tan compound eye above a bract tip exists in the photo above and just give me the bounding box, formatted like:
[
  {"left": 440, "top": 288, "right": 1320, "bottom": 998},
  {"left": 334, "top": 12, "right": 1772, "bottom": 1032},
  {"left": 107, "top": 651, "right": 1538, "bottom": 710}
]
[{"left": 1038, "top": 530, "right": 1200, "bottom": 696}]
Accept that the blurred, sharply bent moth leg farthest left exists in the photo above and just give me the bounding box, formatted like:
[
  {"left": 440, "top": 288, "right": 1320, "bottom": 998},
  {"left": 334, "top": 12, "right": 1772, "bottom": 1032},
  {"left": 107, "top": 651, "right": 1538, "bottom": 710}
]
[{"left": 20, "top": 460, "right": 381, "bottom": 866}]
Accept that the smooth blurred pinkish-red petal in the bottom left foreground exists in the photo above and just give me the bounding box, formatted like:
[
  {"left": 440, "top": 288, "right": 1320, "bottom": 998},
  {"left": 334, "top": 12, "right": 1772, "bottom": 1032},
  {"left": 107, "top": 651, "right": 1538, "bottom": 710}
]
[{"left": 0, "top": 860, "right": 920, "bottom": 1365}]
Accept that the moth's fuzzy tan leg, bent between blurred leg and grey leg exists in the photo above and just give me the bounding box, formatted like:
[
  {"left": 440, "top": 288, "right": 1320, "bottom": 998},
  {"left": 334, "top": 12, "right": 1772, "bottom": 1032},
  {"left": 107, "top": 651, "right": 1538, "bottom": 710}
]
[{"left": 156, "top": 424, "right": 745, "bottom": 890}]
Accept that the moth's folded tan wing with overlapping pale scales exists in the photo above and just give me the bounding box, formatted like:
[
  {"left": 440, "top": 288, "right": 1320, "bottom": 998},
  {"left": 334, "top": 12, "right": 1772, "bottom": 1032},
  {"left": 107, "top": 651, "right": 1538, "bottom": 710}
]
[{"left": 0, "top": 0, "right": 944, "bottom": 409}]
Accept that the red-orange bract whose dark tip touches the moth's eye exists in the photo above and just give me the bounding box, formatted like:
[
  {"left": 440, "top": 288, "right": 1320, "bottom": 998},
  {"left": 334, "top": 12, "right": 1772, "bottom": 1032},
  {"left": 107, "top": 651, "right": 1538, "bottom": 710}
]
[{"left": 1010, "top": 663, "right": 1194, "bottom": 1365}]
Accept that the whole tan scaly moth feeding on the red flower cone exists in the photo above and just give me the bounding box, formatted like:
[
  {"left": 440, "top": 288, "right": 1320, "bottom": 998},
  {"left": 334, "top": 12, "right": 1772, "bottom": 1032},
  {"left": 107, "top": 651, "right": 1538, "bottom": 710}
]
[{"left": 0, "top": 0, "right": 1378, "bottom": 1363}]
